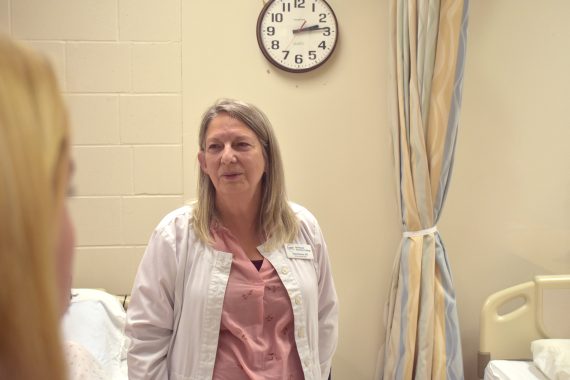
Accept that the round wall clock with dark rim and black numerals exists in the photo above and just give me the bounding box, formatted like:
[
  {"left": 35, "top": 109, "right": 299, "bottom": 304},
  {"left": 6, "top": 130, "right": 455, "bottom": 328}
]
[{"left": 257, "top": 0, "right": 338, "bottom": 72}]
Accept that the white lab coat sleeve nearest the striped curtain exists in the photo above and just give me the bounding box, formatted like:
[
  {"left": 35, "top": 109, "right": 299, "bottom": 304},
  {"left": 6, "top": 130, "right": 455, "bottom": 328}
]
[{"left": 314, "top": 222, "right": 338, "bottom": 380}]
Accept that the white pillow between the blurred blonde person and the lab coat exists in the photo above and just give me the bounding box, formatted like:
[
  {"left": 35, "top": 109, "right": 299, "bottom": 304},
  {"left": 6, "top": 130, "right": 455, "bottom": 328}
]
[{"left": 62, "top": 289, "right": 128, "bottom": 379}]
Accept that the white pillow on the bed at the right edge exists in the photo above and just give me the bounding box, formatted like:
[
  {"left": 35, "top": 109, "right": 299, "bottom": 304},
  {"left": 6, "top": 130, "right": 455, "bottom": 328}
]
[{"left": 530, "top": 339, "right": 570, "bottom": 380}]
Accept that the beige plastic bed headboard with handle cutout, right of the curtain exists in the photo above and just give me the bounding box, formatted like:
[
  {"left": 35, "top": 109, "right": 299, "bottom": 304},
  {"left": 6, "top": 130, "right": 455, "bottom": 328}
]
[{"left": 477, "top": 275, "right": 570, "bottom": 378}]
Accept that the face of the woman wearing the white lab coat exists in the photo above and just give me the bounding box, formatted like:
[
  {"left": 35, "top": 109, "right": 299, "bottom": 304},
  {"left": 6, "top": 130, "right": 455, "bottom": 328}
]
[{"left": 198, "top": 114, "right": 266, "bottom": 203}]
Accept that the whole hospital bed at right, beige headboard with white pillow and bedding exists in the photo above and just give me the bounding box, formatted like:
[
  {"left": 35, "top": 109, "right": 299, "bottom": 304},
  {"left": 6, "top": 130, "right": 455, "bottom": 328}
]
[{"left": 478, "top": 275, "right": 570, "bottom": 380}]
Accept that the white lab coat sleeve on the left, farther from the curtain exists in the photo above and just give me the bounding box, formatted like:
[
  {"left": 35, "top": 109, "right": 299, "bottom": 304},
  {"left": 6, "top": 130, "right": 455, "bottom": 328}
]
[{"left": 126, "top": 228, "right": 177, "bottom": 380}]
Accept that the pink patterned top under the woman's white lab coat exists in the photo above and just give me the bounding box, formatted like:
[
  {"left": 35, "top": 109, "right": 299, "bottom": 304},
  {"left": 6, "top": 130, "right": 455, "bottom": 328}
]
[{"left": 211, "top": 223, "right": 304, "bottom": 380}]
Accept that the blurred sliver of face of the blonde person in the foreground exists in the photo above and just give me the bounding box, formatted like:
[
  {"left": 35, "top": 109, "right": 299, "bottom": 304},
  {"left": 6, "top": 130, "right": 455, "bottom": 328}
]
[{"left": 55, "top": 160, "right": 75, "bottom": 314}]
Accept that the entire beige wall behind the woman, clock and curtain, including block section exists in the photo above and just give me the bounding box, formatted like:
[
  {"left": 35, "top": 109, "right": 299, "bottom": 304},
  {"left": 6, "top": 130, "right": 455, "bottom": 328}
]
[{"left": 0, "top": 0, "right": 570, "bottom": 380}]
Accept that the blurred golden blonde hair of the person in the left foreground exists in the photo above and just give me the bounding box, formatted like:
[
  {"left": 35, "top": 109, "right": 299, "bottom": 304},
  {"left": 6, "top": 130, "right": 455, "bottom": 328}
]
[{"left": 0, "top": 35, "right": 69, "bottom": 380}]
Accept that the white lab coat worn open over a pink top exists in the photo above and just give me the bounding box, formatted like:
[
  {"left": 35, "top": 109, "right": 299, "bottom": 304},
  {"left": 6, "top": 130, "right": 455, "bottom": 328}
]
[{"left": 126, "top": 203, "right": 338, "bottom": 380}]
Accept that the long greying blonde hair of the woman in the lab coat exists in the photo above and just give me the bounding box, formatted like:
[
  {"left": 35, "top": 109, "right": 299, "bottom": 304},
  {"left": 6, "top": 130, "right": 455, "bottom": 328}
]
[{"left": 194, "top": 99, "right": 299, "bottom": 249}]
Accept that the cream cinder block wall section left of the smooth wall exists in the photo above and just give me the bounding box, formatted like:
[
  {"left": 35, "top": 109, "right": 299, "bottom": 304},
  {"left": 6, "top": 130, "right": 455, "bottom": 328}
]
[{"left": 0, "top": 0, "right": 183, "bottom": 292}]
